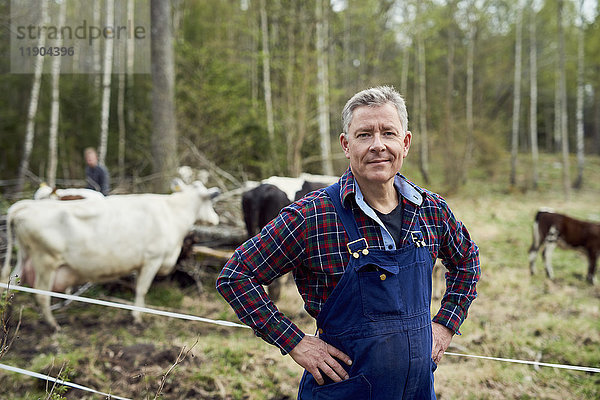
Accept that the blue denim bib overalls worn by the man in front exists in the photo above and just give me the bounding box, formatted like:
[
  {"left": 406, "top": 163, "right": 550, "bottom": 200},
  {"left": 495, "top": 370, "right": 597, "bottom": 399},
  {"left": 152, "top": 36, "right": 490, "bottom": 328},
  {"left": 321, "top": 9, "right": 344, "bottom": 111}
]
[{"left": 298, "top": 184, "right": 436, "bottom": 400}]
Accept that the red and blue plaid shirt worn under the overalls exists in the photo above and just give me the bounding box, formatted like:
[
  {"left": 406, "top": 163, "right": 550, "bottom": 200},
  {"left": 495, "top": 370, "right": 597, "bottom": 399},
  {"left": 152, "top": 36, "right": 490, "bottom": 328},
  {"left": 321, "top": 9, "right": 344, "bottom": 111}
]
[{"left": 217, "top": 169, "right": 480, "bottom": 354}]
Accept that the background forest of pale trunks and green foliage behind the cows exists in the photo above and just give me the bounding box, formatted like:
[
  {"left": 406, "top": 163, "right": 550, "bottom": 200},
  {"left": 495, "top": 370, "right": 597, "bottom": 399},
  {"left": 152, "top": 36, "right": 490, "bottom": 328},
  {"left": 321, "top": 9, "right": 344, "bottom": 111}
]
[{"left": 0, "top": 0, "right": 600, "bottom": 194}]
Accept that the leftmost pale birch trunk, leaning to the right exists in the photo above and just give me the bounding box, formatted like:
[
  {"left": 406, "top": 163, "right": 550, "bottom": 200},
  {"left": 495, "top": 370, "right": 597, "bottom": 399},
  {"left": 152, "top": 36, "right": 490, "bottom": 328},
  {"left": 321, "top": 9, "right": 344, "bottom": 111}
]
[{"left": 16, "top": 1, "right": 48, "bottom": 193}]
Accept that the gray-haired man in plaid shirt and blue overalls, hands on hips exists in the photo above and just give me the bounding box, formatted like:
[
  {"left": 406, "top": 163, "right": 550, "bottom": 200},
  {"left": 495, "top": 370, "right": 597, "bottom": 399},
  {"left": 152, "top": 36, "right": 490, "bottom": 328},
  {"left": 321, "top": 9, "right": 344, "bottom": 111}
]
[{"left": 217, "top": 86, "right": 480, "bottom": 400}]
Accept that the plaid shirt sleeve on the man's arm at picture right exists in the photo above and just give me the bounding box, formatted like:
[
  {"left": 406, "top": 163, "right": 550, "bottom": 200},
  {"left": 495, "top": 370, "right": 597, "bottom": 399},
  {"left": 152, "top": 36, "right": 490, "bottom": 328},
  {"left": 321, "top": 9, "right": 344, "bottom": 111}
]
[{"left": 433, "top": 200, "right": 481, "bottom": 335}]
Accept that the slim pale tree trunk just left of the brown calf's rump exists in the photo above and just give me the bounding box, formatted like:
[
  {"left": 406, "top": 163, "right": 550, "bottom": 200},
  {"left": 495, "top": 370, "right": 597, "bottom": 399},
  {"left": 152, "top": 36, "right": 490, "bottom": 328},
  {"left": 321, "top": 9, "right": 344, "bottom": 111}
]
[{"left": 510, "top": 6, "right": 523, "bottom": 186}]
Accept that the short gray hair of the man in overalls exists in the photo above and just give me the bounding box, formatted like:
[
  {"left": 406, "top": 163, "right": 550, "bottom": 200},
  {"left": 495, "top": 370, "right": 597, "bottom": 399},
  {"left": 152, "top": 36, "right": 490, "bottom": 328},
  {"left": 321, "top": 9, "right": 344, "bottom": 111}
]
[{"left": 342, "top": 86, "right": 408, "bottom": 136}]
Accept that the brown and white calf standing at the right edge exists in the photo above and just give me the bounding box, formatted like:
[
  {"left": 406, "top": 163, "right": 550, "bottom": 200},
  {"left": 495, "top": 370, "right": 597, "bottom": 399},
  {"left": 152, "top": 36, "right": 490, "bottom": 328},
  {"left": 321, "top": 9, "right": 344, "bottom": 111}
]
[{"left": 529, "top": 210, "right": 600, "bottom": 284}]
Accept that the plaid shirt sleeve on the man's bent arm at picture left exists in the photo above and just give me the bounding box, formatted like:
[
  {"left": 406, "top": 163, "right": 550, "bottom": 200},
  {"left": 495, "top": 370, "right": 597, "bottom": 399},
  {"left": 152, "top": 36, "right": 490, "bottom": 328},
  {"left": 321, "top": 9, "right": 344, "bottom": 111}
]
[{"left": 217, "top": 206, "right": 305, "bottom": 354}]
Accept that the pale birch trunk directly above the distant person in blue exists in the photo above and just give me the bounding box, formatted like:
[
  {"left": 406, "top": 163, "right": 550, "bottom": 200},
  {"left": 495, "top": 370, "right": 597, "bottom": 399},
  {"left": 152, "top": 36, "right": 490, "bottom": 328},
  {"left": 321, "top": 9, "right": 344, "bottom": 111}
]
[{"left": 98, "top": 0, "right": 115, "bottom": 165}]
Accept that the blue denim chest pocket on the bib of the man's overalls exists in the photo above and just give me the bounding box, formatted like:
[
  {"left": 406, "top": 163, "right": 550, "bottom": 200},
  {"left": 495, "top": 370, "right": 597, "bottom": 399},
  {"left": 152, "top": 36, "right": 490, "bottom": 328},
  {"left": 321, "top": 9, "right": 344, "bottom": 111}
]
[{"left": 356, "top": 261, "right": 429, "bottom": 321}]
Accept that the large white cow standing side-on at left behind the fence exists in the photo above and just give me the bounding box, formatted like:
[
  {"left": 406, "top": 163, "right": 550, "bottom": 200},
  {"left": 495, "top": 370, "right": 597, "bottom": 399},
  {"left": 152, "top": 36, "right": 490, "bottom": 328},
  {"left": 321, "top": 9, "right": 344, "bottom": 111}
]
[{"left": 1, "top": 182, "right": 219, "bottom": 329}]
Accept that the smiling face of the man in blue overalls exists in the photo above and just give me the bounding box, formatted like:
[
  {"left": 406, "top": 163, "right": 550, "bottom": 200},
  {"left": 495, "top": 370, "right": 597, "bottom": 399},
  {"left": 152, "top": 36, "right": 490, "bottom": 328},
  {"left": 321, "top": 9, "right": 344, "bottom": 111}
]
[{"left": 340, "top": 103, "right": 412, "bottom": 184}]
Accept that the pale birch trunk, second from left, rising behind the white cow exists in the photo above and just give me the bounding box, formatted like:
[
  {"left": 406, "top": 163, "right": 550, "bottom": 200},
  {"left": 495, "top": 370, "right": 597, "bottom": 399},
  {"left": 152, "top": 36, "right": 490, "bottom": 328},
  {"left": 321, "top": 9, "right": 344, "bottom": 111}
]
[{"left": 46, "top": 1, "right": 66, "bottom": 187}]
